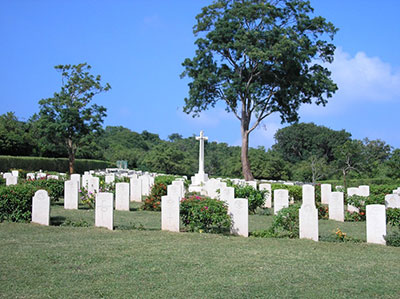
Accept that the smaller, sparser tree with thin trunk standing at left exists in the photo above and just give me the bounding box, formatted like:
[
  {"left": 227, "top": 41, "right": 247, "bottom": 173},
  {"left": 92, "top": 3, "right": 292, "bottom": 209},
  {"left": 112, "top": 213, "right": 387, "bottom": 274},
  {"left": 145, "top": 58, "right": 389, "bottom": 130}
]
[{"left": 39, "top": 63, "right": 111, "bottom": 173}]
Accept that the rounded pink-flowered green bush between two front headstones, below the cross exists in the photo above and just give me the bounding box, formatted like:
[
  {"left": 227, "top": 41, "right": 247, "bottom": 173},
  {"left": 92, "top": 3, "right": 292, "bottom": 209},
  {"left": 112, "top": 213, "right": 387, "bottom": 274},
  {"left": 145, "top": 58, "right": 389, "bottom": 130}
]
[{"left": 180, "top": 195, "right": 231, "bottom": 233}]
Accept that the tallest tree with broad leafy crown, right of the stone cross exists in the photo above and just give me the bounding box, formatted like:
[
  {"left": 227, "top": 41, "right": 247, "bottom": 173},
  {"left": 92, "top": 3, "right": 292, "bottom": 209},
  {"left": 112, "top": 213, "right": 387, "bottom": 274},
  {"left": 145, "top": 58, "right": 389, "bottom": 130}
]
[{"left": 182, "top": 0, "right": 337, "bottom": 180}]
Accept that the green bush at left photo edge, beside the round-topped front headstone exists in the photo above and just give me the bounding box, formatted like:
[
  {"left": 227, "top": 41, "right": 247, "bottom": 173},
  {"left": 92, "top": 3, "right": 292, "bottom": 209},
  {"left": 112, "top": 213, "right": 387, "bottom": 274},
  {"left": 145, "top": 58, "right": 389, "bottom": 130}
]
[{"left": 0, "top": 184, "right": 39, "bottom": 222}]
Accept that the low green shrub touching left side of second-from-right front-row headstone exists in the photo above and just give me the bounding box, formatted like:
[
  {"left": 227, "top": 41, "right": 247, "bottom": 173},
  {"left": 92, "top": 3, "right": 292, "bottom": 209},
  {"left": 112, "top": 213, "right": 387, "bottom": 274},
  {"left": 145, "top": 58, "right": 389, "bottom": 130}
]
[{"left": 270, "top": 203, "right": 300, "bottom": 238}]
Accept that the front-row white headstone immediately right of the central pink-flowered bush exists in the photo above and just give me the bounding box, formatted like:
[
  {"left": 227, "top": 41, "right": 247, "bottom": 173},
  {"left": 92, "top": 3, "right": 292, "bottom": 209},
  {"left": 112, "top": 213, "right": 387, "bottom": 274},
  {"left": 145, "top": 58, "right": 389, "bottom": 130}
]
[{"left": 228, "top": 198, "right": 249, "bottom": 237}]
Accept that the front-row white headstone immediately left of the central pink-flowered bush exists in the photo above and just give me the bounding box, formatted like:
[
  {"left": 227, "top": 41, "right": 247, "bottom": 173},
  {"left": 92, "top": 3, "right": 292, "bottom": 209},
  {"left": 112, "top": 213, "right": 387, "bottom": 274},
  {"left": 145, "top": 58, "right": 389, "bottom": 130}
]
[{"left": 161, "top": 192, "right": 180, "bottom": 232}]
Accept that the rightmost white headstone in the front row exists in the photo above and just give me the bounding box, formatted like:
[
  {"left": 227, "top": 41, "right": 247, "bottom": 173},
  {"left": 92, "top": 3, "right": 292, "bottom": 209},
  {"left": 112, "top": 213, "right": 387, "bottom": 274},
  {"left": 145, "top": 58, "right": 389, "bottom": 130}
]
[{"left": 366, "top": 205, "right": 386, "bottom": 245}]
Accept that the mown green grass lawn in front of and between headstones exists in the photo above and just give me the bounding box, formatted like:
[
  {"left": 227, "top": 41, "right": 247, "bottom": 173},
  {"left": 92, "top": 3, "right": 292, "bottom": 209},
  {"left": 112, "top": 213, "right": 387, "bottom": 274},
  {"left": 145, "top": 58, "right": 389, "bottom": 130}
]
[{"left": 0, "top": 203, "right": 400, "bottom": 298}]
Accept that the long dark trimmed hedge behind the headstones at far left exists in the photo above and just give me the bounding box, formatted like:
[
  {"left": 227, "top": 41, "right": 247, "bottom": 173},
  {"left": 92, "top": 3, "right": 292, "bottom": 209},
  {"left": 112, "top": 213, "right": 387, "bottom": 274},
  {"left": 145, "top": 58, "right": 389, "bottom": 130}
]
[{"left": 0, "top": 156, "right": 115, "bottom": 173}]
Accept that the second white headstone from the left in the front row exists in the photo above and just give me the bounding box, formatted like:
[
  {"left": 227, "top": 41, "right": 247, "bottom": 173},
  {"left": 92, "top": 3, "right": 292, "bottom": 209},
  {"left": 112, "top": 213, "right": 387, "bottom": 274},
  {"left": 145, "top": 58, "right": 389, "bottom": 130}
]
[{"left": 95, "top": 192, "right": 114, "bottom": 230}]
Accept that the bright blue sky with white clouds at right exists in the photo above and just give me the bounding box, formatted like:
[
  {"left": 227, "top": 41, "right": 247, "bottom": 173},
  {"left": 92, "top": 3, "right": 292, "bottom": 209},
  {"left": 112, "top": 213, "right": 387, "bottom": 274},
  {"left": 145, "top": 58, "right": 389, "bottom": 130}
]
[{"left": 0, "top": 0, "right": 400, "bottom": 148}]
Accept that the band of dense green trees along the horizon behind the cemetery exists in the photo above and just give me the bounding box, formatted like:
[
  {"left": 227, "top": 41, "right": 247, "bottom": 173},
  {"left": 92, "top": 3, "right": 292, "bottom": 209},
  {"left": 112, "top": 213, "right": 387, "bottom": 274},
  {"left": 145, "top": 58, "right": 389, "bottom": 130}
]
[{"left": 0, "top": 112, "right": 400, "bottom": 182}]
